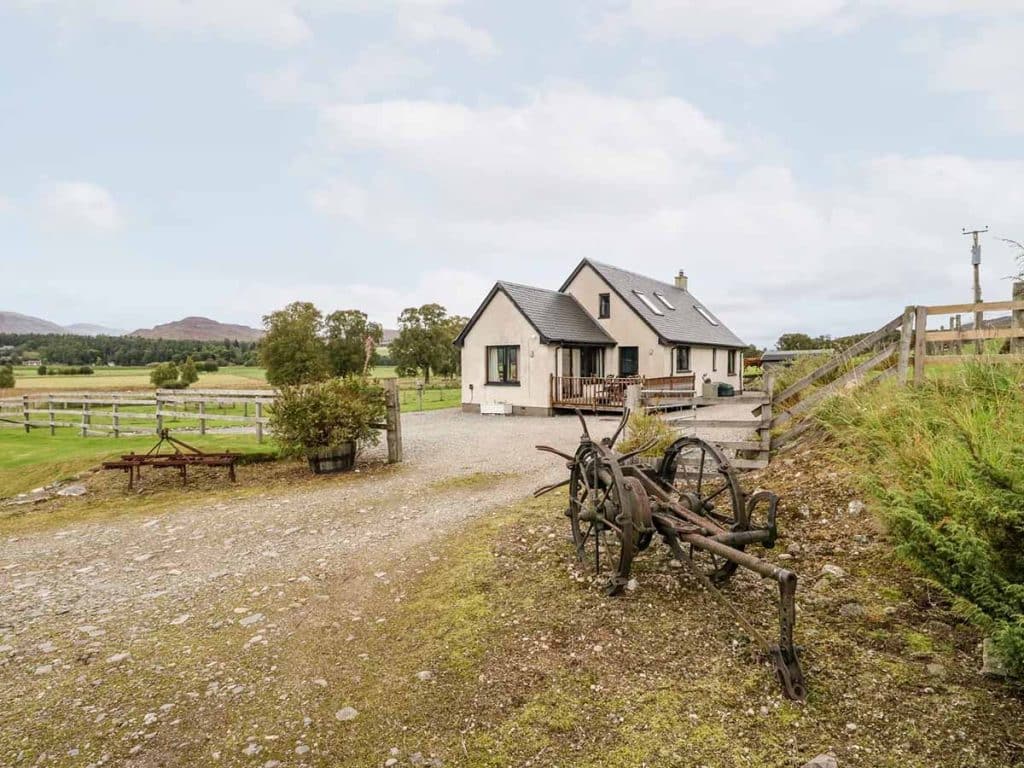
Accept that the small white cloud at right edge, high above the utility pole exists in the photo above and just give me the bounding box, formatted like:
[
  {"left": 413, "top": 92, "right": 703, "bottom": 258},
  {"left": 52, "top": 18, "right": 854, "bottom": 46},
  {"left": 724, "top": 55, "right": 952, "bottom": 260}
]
[{"left": 927, "top": 25, "right": 1024, "bottom": 133}]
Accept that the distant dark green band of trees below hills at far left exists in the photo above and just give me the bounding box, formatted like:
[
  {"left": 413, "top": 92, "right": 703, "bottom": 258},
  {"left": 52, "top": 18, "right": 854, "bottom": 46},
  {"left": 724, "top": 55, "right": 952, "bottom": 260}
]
[{"left": 0, "top": 334, "right": 258, "bottom": 366}]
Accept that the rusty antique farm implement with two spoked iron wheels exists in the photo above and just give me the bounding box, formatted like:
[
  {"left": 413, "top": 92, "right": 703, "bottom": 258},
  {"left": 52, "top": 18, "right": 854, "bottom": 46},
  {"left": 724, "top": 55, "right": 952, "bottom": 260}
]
[{"left": 535, "top": 412, "right": 806, "bottom": 700}]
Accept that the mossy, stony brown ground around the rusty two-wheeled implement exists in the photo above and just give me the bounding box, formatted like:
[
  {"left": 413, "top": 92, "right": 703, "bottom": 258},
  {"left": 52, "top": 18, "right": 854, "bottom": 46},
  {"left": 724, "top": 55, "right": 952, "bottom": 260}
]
[{"left": 0, "top": 448, "right": 1024, "bottom": 768}]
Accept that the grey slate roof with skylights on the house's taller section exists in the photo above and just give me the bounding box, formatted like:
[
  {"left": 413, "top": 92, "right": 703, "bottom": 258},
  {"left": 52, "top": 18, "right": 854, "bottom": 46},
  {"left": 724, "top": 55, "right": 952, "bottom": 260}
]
[{"left": 559, "top": 259, "right": 746, "bottom": 347}]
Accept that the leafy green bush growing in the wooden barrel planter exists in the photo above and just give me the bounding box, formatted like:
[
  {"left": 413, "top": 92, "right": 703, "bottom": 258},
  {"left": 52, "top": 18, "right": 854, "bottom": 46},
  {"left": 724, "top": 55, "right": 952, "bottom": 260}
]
[{"left": 269, "top": 376, "right": 385, "bottom": 456}]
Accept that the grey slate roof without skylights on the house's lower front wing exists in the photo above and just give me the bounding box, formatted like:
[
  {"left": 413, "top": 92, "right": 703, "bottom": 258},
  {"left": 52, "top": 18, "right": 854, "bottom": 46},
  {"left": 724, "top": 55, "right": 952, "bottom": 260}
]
[{"left": 455, "top": 281, "right": 615, "bottom": 346}]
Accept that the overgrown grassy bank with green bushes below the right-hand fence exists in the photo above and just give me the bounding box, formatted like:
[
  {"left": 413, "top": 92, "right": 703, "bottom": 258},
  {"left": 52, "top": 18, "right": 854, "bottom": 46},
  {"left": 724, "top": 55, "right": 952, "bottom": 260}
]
[{"left": 818, "top": 362, "right": 1024, "bottom": 675}]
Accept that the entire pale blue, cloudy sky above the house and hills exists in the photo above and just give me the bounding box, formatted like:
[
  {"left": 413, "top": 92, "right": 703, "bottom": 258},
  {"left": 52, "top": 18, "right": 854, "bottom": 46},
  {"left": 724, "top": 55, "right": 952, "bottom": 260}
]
[{"left": 0, "top": 0, "right": 1024, "bottom": 344}]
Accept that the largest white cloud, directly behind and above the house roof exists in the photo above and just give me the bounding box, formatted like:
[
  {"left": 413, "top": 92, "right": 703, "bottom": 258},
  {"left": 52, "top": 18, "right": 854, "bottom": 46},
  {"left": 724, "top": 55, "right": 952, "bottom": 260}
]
[{"left": 313, "top": 85, "right": 1024, "bottom": 343}]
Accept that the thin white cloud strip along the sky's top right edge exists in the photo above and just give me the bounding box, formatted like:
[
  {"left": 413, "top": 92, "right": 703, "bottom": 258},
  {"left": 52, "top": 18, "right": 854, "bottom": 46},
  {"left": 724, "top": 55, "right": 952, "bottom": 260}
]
[{"left": 594, "top": 0, "right": 1021, "bottom": 43}]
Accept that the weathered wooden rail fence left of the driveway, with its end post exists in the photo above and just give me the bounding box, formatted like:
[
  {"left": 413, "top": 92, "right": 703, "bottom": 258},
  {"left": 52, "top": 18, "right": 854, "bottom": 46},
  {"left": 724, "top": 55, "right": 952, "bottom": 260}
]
[{"left": 0, "top": 379, "right": 401, "bottom": 463}]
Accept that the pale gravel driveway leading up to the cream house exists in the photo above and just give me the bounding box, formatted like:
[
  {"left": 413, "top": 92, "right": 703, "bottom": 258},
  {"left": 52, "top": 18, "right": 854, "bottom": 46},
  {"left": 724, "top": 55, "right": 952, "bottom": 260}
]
[{"left": 0, "top": 407, "right": 761, "bottom": 766}]
